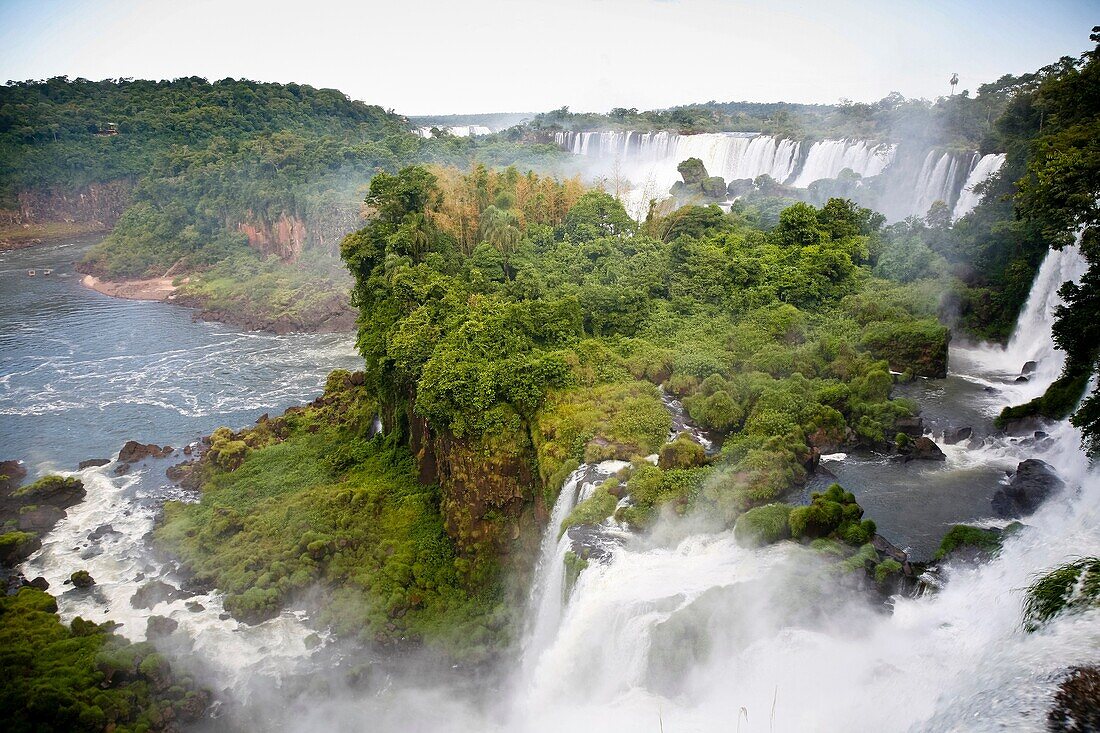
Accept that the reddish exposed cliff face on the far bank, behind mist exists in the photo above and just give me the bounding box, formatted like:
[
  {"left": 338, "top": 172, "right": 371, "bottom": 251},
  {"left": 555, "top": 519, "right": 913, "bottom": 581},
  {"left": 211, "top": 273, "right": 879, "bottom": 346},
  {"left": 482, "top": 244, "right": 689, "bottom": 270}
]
[{"left": 237, "top": 205, "right": 362, "bottom": 262}]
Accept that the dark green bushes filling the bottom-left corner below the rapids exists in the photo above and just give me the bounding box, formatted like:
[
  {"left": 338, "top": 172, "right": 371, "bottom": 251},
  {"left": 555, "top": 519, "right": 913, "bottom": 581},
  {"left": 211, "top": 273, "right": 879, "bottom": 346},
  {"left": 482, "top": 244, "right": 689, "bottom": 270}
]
[{"left": 0, "top": 588, "right": 209, "bottom": 733}]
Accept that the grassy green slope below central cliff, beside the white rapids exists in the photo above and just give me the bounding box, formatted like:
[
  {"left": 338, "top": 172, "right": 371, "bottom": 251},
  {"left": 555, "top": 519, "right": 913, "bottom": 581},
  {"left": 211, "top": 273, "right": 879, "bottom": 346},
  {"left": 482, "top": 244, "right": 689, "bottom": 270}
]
[{"left": 154, "top": 372, "right": 507, "bottom": 658}]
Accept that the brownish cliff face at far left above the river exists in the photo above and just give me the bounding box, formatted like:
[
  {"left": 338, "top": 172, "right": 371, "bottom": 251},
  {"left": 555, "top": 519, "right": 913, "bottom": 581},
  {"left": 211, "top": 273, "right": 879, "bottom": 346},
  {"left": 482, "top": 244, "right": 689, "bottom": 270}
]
[{"left": 12, "top": 180, "right": 133, "bottom": 229}]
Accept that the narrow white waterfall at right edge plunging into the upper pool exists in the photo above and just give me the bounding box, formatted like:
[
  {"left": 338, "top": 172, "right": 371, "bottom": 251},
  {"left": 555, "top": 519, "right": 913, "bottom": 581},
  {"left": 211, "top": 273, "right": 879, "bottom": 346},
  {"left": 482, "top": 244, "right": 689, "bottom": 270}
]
[{"left": 953, "top": 244, "right": 1088, "bottom": 403}]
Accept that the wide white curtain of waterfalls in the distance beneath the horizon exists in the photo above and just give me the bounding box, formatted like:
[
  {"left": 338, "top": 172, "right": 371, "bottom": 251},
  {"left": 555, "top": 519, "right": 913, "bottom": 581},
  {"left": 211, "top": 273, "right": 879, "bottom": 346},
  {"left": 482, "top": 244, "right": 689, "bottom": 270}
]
[{"left": 554, "top": 130, "right": 1004, "bottom": 220}]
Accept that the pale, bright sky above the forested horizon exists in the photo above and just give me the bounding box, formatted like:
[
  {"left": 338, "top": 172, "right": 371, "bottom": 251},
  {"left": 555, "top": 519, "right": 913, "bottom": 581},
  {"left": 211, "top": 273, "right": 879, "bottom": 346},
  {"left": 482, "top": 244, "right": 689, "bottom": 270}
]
[{"left": 0, "top": 0, "right": 1100, "bottom": 114}]
